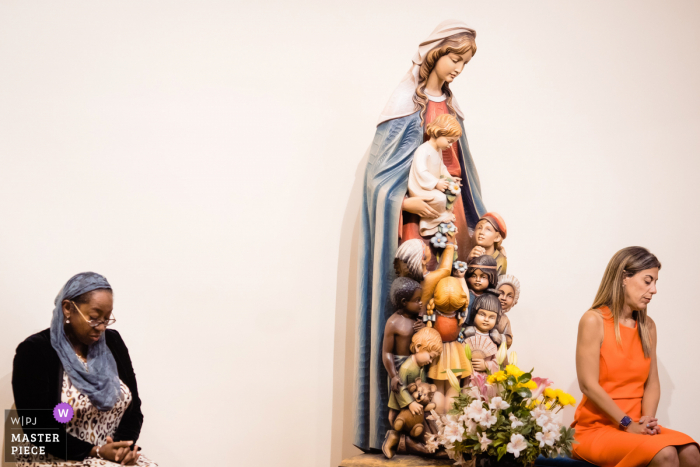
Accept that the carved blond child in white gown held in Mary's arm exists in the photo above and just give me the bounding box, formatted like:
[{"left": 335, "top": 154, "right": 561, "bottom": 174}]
[{"left": 408, "top": 114, "right": 462, "bottom": 237}]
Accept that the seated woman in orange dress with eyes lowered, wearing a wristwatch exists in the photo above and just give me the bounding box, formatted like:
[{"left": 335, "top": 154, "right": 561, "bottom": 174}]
[{"left": 572, "top": 247, "right": 700, "bottom": 467}]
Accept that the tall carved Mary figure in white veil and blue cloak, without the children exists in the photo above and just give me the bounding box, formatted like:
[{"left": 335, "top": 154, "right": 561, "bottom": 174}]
[{"left": 355, "top": 20, "right": 486, "bottom": 451}]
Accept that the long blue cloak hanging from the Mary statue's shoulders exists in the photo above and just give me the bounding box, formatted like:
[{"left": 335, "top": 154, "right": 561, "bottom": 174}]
[{"left": 355, "top": 111, "right": 486, "bottom": 451}]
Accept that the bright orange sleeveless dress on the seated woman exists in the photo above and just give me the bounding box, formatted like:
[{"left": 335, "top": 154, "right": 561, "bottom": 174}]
[{"left": 571, "top": 307, "right": 697, "bottom": 467}]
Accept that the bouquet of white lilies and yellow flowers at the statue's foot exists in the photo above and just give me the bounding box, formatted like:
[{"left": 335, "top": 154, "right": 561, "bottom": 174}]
[{"left": 427, "top": 344, "right": 576, "bottom": 466}]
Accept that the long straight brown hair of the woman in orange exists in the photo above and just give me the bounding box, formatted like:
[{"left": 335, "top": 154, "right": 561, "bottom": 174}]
[{"left": 591, "top": 246, "right": 661, "bottom": 358}]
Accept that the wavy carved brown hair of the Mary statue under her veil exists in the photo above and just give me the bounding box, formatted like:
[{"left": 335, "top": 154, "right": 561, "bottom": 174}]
[{"left": 413, "top": 29, "right": 476, "bottom": 125}]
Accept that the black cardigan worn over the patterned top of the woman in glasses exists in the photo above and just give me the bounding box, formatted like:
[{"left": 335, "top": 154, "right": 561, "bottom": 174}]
[{"left": 12, "top": 329, "right": 143, "bottom": 460}]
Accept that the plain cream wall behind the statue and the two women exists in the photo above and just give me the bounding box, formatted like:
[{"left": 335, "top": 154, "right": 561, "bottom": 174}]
[{"left": 0, "top": 0, "right": 700, "bottom": 467}]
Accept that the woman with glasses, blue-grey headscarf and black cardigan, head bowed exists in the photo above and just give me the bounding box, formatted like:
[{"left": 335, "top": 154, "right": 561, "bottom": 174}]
[{"left": 12, "top": 272, "right": 157, "bottom": 467}]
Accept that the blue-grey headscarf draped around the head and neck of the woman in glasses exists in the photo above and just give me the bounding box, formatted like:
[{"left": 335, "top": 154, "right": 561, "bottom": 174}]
[{"left": 51, "top": 272, "right": 120, "bottom": 411}]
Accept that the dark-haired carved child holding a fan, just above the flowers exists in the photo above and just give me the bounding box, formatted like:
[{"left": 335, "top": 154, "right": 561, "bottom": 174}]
[{"left": 462, "top": 289, "right": 503, "bottom": 373}]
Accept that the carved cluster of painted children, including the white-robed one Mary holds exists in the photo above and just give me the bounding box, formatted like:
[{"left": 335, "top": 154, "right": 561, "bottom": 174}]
[{"left": 382, "top": 114, "right": 520, "bottom": 458}]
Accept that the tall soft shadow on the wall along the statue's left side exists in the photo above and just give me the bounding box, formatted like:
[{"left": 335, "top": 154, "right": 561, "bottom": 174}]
[{"left": 330, "top": 149, "right": 369, "bottom": 466}]
